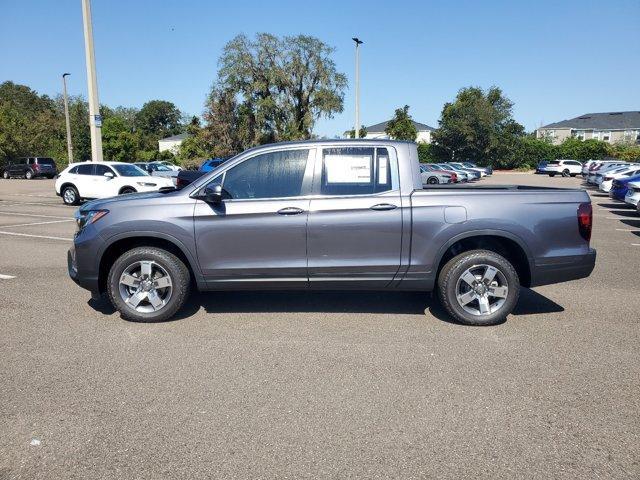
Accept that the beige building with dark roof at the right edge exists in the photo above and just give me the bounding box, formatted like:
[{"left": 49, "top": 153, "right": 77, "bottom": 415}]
[{"left": 536, "top": 111, "right": 640, "bottom": 145}]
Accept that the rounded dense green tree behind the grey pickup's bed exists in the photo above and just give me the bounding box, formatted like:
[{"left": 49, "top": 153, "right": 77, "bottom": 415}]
[{"left": 433, "top": 87, "right": 524, "bottom": 166}]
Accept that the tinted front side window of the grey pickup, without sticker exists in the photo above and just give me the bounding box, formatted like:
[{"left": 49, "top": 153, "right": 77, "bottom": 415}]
[{"left": 222, "top": 149, "right": 309, "bottom": 200}]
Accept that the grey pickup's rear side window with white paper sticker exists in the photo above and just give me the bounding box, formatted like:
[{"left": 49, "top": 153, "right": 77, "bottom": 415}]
[{"left": 320, "top": 147, "right": 394, "bottom": 195}]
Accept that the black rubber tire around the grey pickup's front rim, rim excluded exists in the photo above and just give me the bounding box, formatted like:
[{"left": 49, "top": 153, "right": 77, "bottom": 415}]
[{"left": 107, "top": 247, "right": 191, "bottom": 322}]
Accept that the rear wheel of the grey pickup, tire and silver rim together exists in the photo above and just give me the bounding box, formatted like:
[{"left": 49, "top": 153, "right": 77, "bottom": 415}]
[{"left": 438, "top": 250, "right": 520, "bottom": 325}]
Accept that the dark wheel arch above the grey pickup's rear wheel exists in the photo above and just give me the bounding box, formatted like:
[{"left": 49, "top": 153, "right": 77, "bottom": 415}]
[{"left": 435, "top": 230, "right": 533, "bottom": 287}]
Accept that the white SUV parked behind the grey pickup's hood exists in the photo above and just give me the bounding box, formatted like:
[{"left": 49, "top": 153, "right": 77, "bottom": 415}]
[{"left": 55, "top": 162, "right": 173, "bottom": 205}]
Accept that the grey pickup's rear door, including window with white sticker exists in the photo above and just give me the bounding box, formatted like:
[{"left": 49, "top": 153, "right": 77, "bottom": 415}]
[{"left": 308, "top": 147, "right": 402, "bottom": 288}]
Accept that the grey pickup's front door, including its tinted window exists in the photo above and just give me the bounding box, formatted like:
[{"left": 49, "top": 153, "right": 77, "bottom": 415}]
[{"left": 194, "top": 148, "right": 315, "bottom": 289}]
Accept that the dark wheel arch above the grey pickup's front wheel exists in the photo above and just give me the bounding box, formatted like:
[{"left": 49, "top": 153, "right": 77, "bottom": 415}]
[{"left": 98, "top": 232, "right": 205, "bottom": 292}]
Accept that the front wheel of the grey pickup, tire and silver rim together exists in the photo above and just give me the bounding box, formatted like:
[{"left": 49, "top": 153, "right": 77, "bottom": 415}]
[{"left": 107, "top": 247, "right": 191, "bottom": 322}]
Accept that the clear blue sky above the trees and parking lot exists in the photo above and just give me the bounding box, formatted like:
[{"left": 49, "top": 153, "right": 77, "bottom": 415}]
[{"left": 0, "top": 0, "right": 640, "bottom": 136}]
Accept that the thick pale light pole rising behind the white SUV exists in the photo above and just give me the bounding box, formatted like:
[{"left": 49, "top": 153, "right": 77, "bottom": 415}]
[{"left": 82, "top": 0, "right": 102, "bottom": 162}]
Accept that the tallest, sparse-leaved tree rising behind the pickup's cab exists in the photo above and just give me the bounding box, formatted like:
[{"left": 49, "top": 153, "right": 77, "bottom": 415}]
[{"left": 204, "top": 33, "right": 347, "bottom": 153}]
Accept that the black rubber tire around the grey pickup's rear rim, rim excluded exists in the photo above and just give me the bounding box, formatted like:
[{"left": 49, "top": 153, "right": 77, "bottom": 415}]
[{"left": 438, "top": 250, "right": 520, "bottom": 325}]
